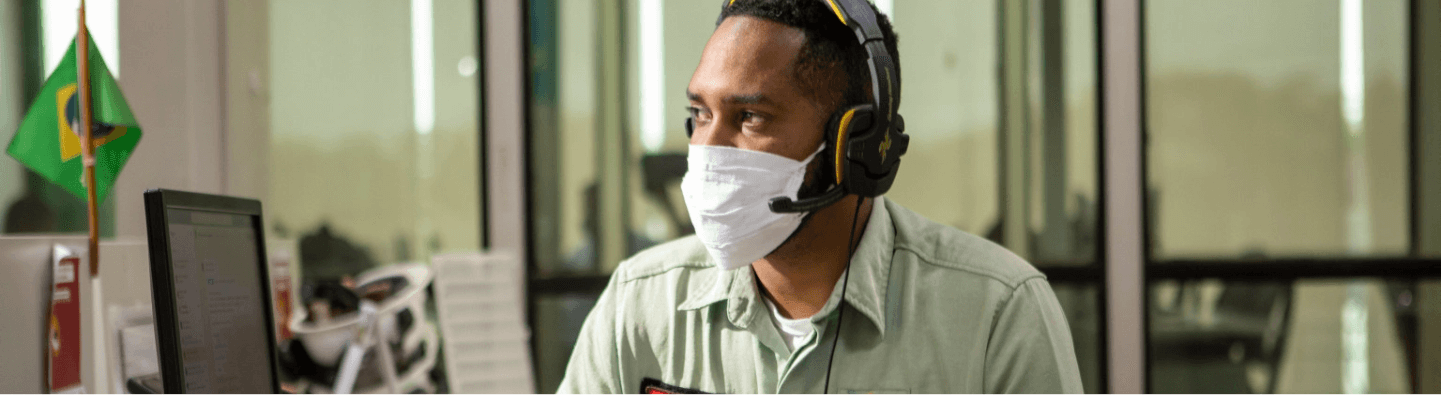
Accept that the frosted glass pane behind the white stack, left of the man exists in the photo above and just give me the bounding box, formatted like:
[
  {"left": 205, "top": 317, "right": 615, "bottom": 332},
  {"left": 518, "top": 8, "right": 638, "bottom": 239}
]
[{"left": 255, "top": 0, "right": 483, "bottom": 278}]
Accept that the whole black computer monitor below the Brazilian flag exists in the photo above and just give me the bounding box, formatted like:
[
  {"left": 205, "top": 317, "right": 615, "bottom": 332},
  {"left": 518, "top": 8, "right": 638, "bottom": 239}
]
[{"left": 146, "top": 189, "right": 280, "bottom": 394}]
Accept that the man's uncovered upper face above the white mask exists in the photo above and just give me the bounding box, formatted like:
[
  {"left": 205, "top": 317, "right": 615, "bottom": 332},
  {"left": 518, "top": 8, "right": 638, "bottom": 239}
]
[{"left": 686, "top": 16, "right": 830, "bottom": 160}]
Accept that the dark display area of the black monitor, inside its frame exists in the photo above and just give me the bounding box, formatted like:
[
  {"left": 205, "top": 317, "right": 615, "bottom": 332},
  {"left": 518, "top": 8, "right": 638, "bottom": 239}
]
[{"left": 157, "top": 208, "right": 274, "bottom": 394}]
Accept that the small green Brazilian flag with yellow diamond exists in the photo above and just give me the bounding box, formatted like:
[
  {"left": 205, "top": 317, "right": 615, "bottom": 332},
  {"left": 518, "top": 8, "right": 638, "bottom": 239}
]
[{"left": 6, "top": 35, "right": 140, "bottom": 202}]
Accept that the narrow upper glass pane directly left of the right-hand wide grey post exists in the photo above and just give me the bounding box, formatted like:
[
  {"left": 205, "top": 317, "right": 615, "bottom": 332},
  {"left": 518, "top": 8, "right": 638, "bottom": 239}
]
[{"left": 997, "top": 0, "right": 1099, "bottom": 267}]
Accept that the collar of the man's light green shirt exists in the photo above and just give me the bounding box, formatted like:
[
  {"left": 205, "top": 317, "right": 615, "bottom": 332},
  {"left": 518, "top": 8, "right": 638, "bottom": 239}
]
[{"left": 677, "top": 198, "right": 895, "bottom": 336}]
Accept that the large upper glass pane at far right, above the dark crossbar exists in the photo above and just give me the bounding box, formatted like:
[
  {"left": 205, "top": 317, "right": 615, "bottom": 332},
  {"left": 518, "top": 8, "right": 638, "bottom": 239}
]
[{"left": 1146, "top": 0, "right": 1409, "bottom": 259}]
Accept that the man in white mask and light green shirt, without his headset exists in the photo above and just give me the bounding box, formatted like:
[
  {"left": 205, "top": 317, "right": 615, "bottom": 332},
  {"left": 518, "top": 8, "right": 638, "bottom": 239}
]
[{"left": 559, "top": 0, "right": 1081, "bottom": 394}]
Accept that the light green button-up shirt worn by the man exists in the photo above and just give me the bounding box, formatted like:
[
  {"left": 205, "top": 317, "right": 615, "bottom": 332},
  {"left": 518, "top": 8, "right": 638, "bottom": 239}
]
[{"left": 559, "top": 199, "right": 1081, "bottom": 394}]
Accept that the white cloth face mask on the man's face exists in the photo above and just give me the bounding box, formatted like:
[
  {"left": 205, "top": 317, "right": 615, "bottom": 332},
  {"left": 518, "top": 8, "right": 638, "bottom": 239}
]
[{"left": 680, "top": 146, "right": 820, "bottom": 270}]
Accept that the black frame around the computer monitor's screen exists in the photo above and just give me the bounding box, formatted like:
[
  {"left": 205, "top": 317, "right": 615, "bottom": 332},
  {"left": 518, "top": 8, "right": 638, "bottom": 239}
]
[{"left": 144, "top": 189, "right": 280, "bottom": 394}]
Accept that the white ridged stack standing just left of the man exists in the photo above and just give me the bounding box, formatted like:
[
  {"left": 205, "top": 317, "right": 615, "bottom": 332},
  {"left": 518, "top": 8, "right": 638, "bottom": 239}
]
[{"left": 431, "top": 252, "right": 535, "bottom": 394}]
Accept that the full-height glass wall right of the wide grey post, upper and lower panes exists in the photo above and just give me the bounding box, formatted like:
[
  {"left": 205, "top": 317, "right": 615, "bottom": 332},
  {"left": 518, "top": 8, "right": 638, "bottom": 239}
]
[{"left": 1144, "top": 0, "right": 1441, "bottom": 394}]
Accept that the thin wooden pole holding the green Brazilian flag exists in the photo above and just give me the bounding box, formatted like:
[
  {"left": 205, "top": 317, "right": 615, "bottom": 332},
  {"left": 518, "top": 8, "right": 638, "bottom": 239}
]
[{"left": 75, "top": 0, "right": 99, "bottom": 278}]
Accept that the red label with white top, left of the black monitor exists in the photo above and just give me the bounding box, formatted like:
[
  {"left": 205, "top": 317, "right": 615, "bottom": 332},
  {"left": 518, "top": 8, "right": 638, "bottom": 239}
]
[{"left": 46, "top": 253, "right": 81, "bottom": 394}]
